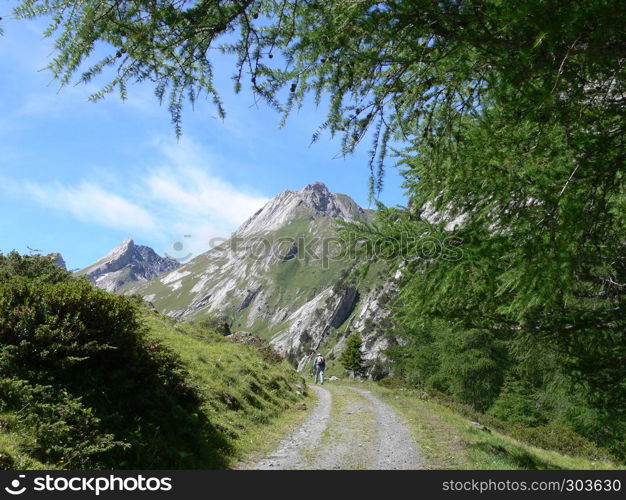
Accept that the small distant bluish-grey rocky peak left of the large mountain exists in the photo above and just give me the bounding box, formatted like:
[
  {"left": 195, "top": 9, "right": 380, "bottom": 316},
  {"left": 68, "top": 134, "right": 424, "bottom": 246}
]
[{"left": 78, "top": 238, "right": 180, "bottom": 292}]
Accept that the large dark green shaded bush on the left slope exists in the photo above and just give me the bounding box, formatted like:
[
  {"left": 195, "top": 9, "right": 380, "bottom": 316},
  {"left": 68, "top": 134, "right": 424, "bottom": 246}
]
[{"left": 0, "top": 253, "right": 227, "bottom": 468}]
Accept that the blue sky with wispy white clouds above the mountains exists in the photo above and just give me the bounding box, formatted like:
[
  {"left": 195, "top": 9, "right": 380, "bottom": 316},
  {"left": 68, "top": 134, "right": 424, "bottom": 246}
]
[{"left": 0, "top": 13, "right": 405, "bottom": 268}]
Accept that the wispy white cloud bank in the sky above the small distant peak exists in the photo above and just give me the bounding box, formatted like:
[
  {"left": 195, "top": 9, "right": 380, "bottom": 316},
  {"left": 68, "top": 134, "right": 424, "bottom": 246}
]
[{"left": 0, "top": 139, "right": 268, "bottom": 258}]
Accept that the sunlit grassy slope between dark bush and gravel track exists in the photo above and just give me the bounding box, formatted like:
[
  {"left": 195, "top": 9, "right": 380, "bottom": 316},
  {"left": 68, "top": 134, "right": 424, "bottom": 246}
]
[{"left": 141, "top": 313, "right": 307, "bottom": 464}]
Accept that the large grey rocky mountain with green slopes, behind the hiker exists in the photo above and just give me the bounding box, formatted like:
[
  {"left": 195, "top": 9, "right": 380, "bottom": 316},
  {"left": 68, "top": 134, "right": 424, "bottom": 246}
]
[{"left": 123, "top": 183, "right": 392, "bottom": 376}]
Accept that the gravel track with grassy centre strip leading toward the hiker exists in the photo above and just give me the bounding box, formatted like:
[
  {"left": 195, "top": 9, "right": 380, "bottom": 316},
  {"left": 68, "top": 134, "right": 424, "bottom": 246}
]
[{"left": 242, "top": 384, "right": 423, "bottom": 470}]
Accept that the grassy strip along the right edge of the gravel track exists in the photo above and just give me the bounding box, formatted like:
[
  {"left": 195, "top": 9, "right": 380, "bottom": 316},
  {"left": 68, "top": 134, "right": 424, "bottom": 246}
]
[{"left": 366, "top": 382, "right": 623, "bottom": 470}]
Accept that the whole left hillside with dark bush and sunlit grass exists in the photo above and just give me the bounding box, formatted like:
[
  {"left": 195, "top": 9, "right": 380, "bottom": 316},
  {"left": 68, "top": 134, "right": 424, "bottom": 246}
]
[{"left": 0, "top": 253, "right": 305, "bottom": 469}]
